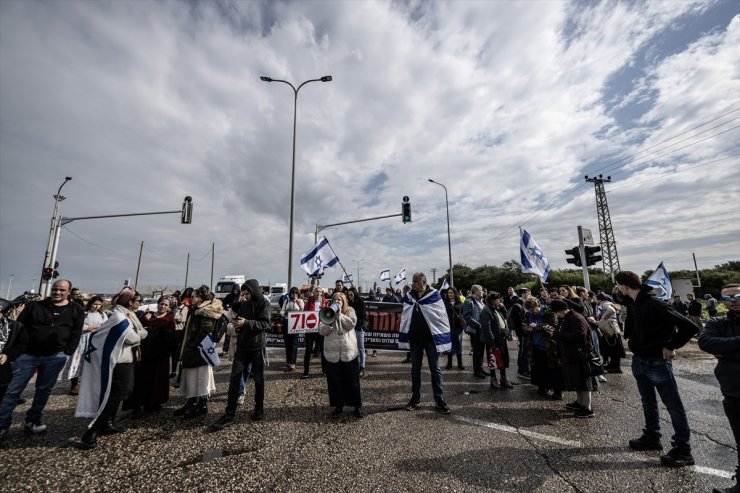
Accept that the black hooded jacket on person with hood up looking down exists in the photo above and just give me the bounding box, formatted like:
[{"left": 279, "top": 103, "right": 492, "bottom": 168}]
[{"left": 234, "top": 279, "right": 272, "bottom": 353}]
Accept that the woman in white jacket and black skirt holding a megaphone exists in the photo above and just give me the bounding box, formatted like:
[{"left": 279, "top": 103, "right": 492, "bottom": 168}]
[{"left": 319, "top": 291, "right": 365, "bottom": 418}]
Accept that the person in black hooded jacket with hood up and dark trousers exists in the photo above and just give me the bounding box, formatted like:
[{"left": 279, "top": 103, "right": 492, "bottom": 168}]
[{"left": 209, "top": 279, "right": 271, "bottom": 431}]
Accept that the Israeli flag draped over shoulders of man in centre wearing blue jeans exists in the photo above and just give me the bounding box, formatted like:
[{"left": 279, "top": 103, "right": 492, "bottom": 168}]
[{"left": 398, "top": 289, "right": 452, "bottom": 352}]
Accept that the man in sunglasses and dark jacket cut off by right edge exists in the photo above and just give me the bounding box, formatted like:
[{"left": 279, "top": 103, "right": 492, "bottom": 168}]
[{"left": 699, "top": 284, "right": 740, "bottom": 493}]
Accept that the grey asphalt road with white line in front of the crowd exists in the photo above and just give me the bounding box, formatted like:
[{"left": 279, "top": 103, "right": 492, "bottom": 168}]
[{"left": 0, "top": 343, "right": 737, "bottom": 492}]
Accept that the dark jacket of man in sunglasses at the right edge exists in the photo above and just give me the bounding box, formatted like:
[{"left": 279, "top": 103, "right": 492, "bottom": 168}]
[{"left": 699, "top": 312, "right": 740, "bottom": 399}]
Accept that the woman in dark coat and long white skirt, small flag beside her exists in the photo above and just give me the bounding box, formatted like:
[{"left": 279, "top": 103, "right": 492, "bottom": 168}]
[{"left": 175, "top": 284, "right": 223, "bottom": 419}]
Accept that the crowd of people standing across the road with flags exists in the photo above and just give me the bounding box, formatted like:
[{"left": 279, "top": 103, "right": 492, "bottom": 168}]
[{"left": 0, "top": 271, "right": 740, "bottom": 491}]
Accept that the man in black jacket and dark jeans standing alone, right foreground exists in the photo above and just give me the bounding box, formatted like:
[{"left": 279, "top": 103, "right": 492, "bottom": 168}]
[{"left": 614, "top": 271, "right": 699, "bottom": 467}]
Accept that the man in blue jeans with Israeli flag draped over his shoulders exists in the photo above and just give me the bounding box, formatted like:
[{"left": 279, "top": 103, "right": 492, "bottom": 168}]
[{"left": 398, "top": 272, "right": 452, "bottom": 414}]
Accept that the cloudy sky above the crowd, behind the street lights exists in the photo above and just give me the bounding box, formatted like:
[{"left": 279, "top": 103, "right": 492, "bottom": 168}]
[{"left": 0, "top": 0, "right": 740, "bottom": 296}]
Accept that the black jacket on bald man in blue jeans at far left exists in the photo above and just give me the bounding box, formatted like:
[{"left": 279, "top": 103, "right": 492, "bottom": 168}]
[{"left": 18, "top": 300, "right": 85, "bottom": 356}]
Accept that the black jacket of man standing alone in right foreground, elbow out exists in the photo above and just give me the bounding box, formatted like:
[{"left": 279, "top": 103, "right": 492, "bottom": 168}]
[{"left": 624, "top": 284, "right": 700, "bottom": 358}]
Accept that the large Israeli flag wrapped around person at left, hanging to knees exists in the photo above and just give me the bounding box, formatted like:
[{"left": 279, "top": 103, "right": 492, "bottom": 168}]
[{"left": 75, "top": 307, "right": 135, "bottom": 424}]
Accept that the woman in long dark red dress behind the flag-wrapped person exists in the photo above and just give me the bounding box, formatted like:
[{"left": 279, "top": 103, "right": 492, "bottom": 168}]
[{"left": 123, "top": 296, "right": 175, "bottom": 418}]
